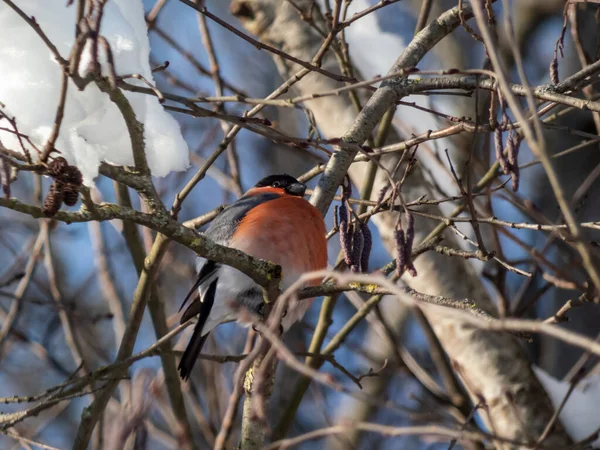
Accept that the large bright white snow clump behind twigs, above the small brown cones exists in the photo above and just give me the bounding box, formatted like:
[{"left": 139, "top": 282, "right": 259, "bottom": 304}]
[{"left": 0, "top": 0, "right": 189, "bottom": 184}]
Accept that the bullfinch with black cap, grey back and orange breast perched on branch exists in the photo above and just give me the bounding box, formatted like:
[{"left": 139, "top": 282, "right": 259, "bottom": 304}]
[{"left": 178, "top": 174, "right": 327, "bottom": 381}]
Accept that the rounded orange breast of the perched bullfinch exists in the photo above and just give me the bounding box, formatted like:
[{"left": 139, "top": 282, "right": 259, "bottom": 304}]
[{"left": 230, "top": 196, "right": 327, "bottom": 284}]
